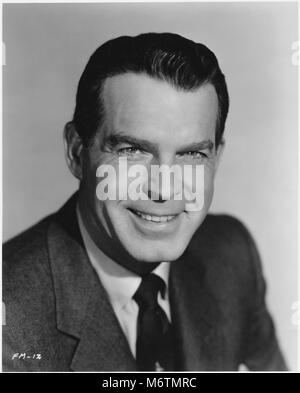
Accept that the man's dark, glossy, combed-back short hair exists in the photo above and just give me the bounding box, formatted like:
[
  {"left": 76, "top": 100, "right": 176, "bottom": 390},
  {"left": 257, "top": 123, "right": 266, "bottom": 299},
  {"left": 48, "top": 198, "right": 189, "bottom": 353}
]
[{"left": 73, "top": 33, "right": 229, "bottom": 146}]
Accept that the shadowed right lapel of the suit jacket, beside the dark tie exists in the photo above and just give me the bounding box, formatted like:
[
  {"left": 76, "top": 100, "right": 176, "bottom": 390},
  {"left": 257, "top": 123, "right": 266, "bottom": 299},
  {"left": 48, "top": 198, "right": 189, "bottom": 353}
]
[{"left": 170, "top": 249, "right": 223, "bottom": 371}]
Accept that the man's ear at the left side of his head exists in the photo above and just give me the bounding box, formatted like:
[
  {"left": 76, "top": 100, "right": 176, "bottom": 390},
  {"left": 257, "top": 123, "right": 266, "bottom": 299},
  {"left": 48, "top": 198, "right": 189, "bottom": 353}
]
[{"left": 64, "top": 122, "right": 83, "bottom": 180}]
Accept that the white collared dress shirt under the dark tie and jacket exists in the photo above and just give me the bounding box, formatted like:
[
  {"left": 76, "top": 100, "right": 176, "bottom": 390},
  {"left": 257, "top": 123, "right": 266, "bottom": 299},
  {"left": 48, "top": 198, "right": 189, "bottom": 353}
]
[{"left": 77, "top": 206, "right": 171, "bottom": 357}]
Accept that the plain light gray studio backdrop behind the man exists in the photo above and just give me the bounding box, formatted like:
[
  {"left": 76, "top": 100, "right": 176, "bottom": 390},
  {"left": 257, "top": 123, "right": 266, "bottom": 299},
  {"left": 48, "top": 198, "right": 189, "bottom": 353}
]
[{"left": 3, "top": 3, "right": 297, "bottom": 369}]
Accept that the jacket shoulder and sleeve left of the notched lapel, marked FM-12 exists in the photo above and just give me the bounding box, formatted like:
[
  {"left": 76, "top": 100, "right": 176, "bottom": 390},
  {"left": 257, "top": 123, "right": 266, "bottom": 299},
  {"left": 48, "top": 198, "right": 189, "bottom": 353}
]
[{"left": 2, "top": 198, "right": 79, "bottom": 371}]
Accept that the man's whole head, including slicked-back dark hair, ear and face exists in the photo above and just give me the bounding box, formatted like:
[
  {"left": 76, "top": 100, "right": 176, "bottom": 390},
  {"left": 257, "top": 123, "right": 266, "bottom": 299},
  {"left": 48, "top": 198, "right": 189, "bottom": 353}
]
[{"left": 65, "top": 33, "right": 228, "bottom": 262}]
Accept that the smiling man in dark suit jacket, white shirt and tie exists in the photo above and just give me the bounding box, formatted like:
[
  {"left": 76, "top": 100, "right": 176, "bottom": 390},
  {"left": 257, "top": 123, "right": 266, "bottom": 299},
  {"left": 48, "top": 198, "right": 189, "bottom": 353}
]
[{"left": 3, "top": 33, "right": 286, "bottom": 371}]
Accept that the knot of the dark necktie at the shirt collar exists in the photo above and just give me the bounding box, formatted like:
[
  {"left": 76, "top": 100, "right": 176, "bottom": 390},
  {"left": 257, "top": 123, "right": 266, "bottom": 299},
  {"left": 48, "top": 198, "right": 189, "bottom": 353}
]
[{"left": 133, "top": 273, "right": 166, "bottom": 308}]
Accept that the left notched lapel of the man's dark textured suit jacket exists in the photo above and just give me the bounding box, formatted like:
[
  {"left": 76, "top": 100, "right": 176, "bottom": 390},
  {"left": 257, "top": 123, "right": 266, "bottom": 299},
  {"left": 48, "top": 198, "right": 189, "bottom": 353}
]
[{"left": 48, "top": 195, "right": 136, "bottom": 371}]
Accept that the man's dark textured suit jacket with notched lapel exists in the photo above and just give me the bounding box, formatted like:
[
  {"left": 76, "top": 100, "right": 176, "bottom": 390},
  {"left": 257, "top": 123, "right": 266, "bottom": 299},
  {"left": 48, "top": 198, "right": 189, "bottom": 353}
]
[{"left": 3, "top": 194, "right": 286, "bottom": 371}]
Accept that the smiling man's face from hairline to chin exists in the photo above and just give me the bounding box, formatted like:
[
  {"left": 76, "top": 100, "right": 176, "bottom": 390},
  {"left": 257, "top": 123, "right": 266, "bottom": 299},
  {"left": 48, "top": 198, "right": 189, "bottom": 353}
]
[{"left": 80, "top": 73, "right": 218, "bottom": 262}]
